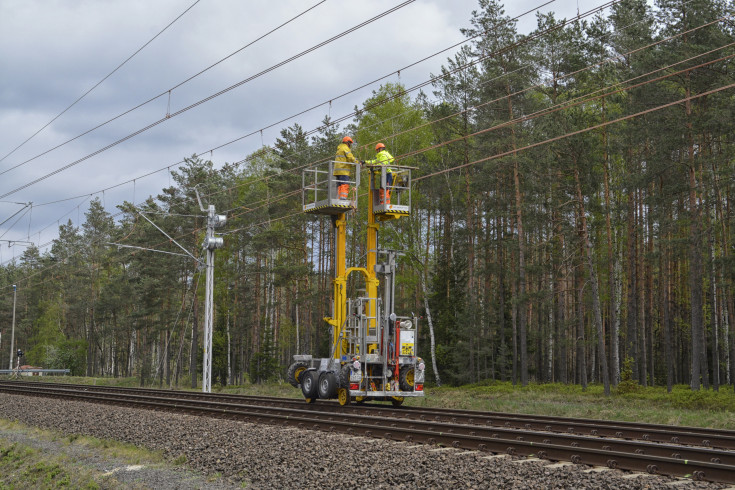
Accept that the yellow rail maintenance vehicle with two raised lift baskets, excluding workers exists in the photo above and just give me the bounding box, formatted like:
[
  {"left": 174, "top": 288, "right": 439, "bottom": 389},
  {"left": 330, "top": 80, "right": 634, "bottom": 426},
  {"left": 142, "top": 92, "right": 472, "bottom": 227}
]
[{"left": 287, "top": 154, "right": 426, "bottom": 406}]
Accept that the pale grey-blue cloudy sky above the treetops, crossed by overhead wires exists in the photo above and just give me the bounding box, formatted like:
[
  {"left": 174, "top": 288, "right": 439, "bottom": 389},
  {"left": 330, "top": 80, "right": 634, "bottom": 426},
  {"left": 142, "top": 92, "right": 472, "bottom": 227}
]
[{"left": 0, "top": 0, "right": 606, "bottom": 263}]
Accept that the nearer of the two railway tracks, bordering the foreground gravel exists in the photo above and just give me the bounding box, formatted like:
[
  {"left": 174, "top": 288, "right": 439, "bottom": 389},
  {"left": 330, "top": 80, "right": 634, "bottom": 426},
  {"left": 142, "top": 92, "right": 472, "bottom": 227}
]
[{"left": 0, "top": 383, "right": 735, "bottom": 482}]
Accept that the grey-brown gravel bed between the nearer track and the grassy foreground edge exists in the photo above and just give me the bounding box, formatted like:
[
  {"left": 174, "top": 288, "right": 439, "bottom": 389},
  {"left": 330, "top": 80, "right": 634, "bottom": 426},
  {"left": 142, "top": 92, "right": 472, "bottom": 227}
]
[{"left": 0, "top": 393, "right": 726, "bottom": 489}]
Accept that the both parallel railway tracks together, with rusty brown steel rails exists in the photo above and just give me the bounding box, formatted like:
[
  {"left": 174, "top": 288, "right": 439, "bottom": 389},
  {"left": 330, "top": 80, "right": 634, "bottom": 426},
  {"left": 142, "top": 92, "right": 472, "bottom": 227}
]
[{"left": 0, "top": 381, "right": 735, "bottom": 483}]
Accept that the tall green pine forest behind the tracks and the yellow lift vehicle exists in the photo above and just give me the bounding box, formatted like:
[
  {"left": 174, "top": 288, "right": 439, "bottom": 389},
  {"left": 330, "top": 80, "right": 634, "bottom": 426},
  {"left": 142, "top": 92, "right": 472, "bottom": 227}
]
[{"left": 0, "top": 0, "right": 735, "bottom": 393}]
